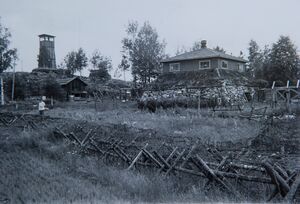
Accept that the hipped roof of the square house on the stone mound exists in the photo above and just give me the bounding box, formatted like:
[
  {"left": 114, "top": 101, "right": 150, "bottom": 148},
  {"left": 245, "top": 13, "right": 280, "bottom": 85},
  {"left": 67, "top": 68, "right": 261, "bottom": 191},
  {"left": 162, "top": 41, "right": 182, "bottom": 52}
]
[{"left": 161, "top": 48, "right": 247, "bottom": 63}]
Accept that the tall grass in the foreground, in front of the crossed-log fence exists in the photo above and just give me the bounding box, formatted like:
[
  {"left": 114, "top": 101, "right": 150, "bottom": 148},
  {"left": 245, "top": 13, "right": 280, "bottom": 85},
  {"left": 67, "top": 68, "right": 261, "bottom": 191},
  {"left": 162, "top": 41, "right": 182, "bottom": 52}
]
[{"left": 0, "top": 126, "right": 234, "bottom": 203}]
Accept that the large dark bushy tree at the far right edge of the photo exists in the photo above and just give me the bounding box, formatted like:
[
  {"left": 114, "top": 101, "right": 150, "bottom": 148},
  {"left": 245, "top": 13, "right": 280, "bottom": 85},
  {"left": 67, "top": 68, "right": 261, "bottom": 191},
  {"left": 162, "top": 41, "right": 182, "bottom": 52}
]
[{"left": 266, "top": 36, "right": 299, "bottom": 83}]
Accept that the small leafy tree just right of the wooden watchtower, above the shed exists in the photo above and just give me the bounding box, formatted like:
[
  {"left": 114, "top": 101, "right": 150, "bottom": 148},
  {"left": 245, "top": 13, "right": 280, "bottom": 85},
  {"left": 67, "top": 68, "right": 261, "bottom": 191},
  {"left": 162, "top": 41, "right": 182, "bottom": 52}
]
[{"left": 64, "top": 48, "right": 88, "bottom": 74}]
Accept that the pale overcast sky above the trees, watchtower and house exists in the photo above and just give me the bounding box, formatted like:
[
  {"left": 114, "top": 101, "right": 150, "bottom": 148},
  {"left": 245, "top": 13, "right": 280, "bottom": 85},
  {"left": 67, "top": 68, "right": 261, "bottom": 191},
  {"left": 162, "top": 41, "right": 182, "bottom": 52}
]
[{"left": 0, "top": 0, "right": 300, "bottom": 79}]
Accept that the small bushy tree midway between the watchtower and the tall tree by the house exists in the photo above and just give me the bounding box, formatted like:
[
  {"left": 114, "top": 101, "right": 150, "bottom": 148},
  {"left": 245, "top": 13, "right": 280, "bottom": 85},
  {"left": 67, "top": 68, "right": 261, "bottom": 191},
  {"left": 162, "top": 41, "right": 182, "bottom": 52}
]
[{"left": 90, "top": 50, "right": 112, "bottom": 81}]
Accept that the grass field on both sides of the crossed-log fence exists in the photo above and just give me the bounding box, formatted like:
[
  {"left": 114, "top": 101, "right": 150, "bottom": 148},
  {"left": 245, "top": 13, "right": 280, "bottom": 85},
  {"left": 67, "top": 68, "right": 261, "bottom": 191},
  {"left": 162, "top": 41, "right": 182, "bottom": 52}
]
[{"left": 0, "top": 101, "right": 300, "bottom": 203}]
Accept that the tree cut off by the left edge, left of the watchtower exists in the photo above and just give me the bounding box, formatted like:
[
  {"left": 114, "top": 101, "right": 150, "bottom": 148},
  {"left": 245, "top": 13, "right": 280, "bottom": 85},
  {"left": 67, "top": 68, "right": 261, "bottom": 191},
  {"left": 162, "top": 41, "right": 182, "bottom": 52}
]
[{"left": 0, "top": 18, "right": 18, "bottom": 73}]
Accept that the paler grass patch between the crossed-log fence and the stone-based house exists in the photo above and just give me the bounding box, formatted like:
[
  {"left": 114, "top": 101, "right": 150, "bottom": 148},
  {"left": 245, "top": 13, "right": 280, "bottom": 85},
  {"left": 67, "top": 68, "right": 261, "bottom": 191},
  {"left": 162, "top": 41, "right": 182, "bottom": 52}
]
[{"left": 47, "top": 102, "right": 260, "bottom": 142}]
